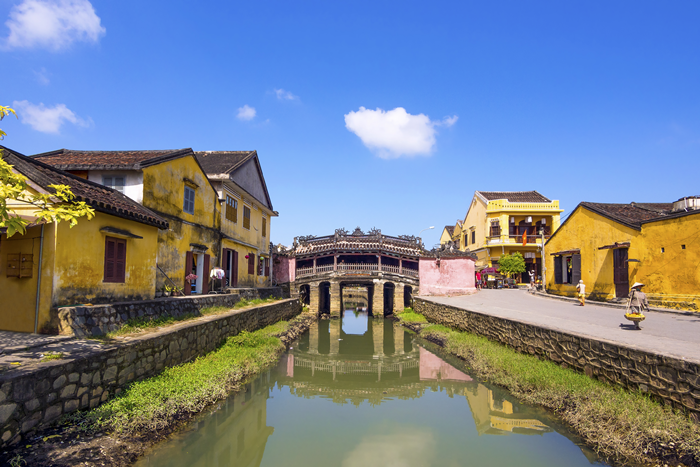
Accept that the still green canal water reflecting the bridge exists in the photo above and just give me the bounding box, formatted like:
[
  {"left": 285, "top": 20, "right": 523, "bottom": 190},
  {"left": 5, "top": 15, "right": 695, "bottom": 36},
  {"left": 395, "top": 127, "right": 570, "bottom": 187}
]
[{"left": 137, "top": 310, "right": 604, "bottom": 467}]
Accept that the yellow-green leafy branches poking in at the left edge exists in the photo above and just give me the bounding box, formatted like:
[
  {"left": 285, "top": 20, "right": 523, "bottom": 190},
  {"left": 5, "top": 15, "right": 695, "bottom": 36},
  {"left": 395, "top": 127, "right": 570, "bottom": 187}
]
[{"left": 0, "top": 106, "right": 95, "bottom": 238}]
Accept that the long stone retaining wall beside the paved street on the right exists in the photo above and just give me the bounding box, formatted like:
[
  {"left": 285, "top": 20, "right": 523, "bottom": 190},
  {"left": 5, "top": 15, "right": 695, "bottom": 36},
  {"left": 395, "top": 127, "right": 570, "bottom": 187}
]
[{"left": 414, "top": 298, "right": 700, "bottom": 421}]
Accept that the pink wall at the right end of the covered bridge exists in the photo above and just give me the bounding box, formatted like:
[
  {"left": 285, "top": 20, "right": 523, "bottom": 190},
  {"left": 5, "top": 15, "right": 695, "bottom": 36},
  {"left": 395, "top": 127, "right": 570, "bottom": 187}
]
[{"left": 418, "top": 258, "right": 476, "bottom": 295}]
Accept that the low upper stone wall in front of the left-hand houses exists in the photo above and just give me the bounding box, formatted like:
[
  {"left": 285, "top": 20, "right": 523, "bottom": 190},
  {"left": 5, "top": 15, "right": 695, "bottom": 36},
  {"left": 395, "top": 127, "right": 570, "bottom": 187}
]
[{"left": 57, "top": 287, "right": 285, "bottom": 337}]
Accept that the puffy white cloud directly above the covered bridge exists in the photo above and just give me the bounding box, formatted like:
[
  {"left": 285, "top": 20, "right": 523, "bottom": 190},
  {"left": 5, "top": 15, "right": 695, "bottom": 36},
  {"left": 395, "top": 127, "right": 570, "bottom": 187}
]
[{"left": 345, "top": 107, "right": 458, "bottom": 159}]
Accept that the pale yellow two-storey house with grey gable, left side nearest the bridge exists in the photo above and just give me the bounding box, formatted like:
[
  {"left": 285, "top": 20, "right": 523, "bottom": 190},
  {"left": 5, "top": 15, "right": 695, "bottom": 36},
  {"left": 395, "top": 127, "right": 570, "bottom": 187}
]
[{"left": 197, "top": 151, "right": 278, "bottom": 287}]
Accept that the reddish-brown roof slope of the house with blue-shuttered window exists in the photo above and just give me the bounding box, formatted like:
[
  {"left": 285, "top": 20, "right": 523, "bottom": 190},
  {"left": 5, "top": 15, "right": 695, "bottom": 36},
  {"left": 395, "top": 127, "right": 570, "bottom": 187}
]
[{"left": 31, "top": 148, "right": 193, "bottom": 170}]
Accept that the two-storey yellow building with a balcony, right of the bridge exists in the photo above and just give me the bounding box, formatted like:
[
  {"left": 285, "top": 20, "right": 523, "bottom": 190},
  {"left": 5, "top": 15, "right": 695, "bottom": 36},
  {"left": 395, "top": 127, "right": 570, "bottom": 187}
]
[{"left": 459, "top": 191, "right": 562, "bottom": 282}]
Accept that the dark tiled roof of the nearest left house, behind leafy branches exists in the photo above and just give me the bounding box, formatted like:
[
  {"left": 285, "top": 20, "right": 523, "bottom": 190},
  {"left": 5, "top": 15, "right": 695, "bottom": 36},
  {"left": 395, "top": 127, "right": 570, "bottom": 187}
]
[{"left": 0, "top": 146, "right": 168, "bottom": 229}]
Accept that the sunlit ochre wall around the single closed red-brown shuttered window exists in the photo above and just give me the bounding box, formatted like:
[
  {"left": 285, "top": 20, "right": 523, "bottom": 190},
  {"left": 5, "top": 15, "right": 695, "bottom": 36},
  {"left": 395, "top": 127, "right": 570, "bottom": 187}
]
[{"left": 52, "top": 212, "right": 158, "bottom": 307}]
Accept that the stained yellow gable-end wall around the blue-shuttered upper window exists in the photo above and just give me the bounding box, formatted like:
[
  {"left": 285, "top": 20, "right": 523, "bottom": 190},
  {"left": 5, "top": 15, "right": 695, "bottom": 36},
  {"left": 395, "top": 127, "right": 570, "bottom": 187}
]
[{"left": 143, "top": 156, "right": 221, "bottom": 288}]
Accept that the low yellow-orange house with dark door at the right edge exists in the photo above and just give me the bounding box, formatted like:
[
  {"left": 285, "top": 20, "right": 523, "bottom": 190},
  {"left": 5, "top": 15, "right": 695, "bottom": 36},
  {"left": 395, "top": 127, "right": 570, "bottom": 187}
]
[{"left": 545, "top": 197, "right": 700, "bottom": 310}]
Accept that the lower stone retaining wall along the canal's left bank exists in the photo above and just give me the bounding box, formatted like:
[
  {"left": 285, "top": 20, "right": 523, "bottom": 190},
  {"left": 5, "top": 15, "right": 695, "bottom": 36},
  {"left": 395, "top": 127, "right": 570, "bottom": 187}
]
[{"left": 0, "top": 299, "right": 301, "bottom": 447}]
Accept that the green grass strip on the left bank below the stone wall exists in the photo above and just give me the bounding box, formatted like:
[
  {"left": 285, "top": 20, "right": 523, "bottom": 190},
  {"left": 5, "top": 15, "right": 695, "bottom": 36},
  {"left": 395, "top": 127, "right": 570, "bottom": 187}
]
[{"left": 69, "top": 320, "right": 294, "bottom": 433}]
